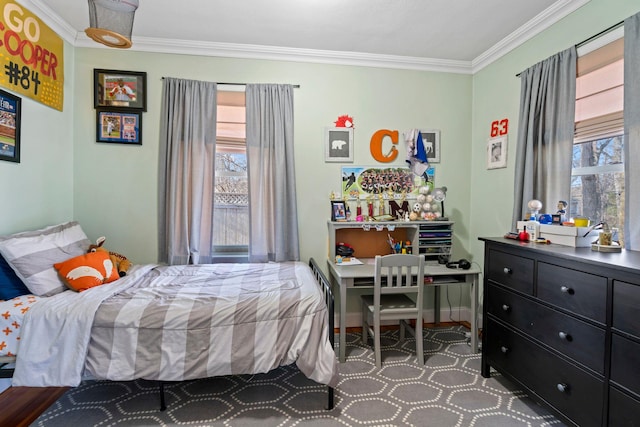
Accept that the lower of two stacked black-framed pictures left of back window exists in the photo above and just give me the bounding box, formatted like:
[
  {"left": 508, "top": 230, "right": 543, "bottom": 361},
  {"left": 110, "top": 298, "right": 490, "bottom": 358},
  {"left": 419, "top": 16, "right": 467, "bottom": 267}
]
[{"left": 96, "top": 110, "right": 142, "bottom": 145}]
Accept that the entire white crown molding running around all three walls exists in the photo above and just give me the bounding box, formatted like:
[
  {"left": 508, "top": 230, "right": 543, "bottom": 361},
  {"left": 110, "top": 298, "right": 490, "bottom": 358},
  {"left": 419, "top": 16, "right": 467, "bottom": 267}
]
[{"left": 16, "top": 0, "right": 591, "bottom": 74}]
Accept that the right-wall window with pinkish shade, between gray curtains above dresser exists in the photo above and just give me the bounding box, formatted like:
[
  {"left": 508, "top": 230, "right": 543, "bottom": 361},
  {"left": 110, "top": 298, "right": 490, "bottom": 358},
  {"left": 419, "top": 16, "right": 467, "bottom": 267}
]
[{"left": 569, "top": 28, "right": 624, "bottom": 239}]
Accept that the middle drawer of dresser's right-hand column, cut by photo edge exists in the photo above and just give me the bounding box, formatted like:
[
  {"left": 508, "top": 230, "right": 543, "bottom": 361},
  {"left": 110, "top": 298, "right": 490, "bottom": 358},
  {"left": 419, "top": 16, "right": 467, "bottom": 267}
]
[{"left": 611, "top": 334, "right": 640, "bottom": 395}]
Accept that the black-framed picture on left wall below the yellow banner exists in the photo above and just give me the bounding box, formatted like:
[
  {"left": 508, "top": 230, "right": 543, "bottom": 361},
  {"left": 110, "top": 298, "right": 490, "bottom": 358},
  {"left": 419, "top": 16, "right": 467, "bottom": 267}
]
[{"left": 0, "top": 89, "right": 22, "bottom": 163}]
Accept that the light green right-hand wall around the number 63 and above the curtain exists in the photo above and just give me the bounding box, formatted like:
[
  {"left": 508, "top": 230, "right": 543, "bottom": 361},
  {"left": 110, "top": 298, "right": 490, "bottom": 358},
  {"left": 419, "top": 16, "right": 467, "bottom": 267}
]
[{"left": 468, "top": 0, "right": 640, "bottom": 263}]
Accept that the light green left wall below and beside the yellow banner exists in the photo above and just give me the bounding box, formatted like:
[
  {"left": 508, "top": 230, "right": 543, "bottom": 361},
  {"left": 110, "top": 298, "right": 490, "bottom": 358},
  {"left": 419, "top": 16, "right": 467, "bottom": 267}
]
[{"left": 0, "top": 43, "right": 74, "bottom": 235}]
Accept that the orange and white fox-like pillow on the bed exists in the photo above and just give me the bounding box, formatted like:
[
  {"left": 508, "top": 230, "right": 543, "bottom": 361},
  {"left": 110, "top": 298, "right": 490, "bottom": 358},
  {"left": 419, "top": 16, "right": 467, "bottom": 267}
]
[{"left": 53, "top": 251, "right": 120, "bottom": 292}]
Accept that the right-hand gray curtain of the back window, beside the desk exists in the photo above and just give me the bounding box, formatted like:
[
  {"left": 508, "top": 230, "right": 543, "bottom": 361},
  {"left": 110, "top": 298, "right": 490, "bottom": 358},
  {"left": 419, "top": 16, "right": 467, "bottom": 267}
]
[{"left": 246, "top": 84, "right": 300, "bottom": 262}]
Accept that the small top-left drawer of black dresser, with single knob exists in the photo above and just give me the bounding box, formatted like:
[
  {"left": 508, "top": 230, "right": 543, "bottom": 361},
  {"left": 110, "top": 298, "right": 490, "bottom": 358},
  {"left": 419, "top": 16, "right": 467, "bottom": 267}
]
[{"left": 486, "top": 250, "right": 534, "bottom": 294}]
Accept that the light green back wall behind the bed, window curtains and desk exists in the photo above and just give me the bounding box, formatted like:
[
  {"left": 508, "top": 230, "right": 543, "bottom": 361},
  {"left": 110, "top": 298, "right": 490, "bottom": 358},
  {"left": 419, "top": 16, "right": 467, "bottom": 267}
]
[{"left": 74, "top": 49, "right": 471, "bottom": 263}]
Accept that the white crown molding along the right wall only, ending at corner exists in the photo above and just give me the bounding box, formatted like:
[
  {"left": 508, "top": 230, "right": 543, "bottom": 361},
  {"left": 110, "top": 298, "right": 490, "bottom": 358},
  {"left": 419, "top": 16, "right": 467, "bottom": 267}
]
[{"left": 471, "top": 0, "right": 591, "bottom": 74}]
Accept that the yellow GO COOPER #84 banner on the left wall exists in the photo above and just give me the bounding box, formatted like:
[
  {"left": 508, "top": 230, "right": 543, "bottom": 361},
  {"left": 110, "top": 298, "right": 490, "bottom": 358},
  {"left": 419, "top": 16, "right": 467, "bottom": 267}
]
[{"left": 0, "top": 0, "right": 64, "bottom": 111}]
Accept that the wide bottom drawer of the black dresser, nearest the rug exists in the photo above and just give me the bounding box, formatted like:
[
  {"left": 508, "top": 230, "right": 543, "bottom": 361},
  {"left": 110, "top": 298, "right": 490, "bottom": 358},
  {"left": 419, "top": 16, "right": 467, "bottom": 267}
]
[{"left": 482, "top": 319, "right": 605, "bottom": 427}]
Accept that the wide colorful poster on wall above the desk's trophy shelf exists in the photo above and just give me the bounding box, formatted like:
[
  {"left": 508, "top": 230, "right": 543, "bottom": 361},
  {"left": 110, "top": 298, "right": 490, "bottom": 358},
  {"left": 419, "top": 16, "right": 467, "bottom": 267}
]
[{"left": 341, "top": 166, "right": 435, "bottom": 200}]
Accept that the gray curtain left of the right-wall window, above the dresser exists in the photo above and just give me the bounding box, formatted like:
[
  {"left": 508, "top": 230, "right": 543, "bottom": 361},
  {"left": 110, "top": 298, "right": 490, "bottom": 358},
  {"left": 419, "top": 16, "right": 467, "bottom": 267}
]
[{"left": 513, "top": 46, "right": 577, "bottom": 229}]
